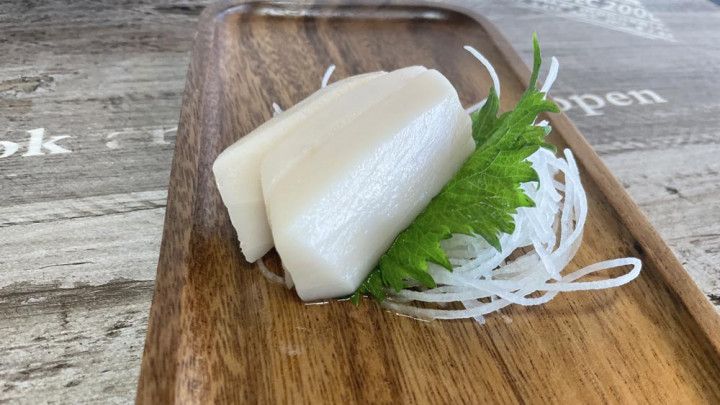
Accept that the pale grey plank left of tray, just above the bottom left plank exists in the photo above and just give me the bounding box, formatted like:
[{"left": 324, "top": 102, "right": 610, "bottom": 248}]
[{"left": 0, "top": 208, "right": 164, "bottom": 288}]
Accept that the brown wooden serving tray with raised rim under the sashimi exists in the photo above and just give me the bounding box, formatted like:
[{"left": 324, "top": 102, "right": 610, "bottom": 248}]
[{"left": 137, "top": 2, "right": 720, "bottom": 404}]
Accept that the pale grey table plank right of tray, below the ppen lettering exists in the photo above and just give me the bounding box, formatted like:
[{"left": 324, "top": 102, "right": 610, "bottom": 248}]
[{"left": 605, "top": 144, "right": 720, "bottom": 302}]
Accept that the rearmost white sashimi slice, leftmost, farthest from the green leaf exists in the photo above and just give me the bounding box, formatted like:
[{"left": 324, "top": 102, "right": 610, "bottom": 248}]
[{"left": 213, "top": 72, "right": 385, "bottom": 262}]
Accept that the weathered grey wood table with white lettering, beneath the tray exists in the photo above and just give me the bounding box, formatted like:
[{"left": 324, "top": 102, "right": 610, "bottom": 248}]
[{"left": 0, "top": 0, "right": 720, "bottom": 403}]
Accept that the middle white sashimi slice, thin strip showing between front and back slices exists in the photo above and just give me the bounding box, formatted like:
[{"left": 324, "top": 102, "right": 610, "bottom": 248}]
[{"left": 261, "top": 66, "right": 427, "bottom": 200}]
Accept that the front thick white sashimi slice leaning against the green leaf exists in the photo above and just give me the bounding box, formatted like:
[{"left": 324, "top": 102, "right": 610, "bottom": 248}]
[{"left": 261, "top": 70, "right": 475, "bottom": 300}]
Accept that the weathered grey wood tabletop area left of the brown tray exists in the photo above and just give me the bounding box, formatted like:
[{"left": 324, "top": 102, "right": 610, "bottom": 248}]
[{"left": 0, "top": 0, "right": 207, "bottom": 404}]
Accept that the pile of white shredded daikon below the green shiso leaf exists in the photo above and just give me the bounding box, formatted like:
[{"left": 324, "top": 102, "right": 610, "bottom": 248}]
[{"left": 383, "top": 149, "right": 641, "bottom": 322}]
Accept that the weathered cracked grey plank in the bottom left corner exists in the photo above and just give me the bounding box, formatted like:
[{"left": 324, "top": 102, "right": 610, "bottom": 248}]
[{"left": 0, "top": 281, "right": 153, "bottom": 404}]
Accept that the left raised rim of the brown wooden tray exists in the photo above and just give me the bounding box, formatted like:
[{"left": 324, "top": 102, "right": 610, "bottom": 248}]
[{"left": 135, "top": 1, "right": 234, "bottom": 404}]
